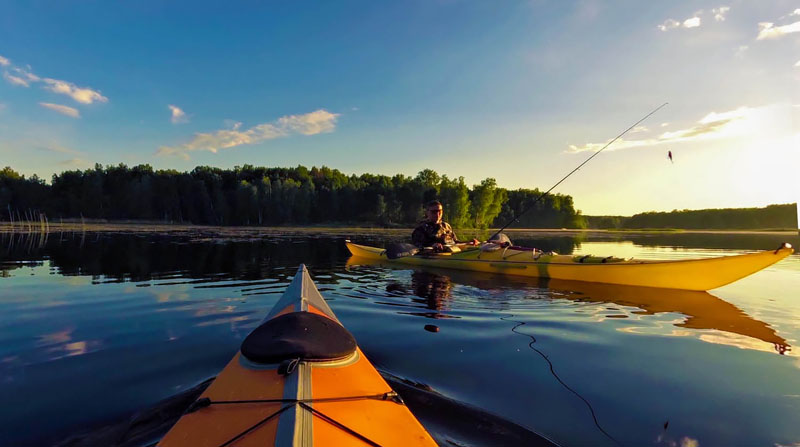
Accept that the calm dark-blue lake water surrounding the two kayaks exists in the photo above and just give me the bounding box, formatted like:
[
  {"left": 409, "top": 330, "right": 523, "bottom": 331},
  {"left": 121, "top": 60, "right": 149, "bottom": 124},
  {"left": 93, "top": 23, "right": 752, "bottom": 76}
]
[{"left": 0, "top": 233, "right": 800, "bottom": 447}]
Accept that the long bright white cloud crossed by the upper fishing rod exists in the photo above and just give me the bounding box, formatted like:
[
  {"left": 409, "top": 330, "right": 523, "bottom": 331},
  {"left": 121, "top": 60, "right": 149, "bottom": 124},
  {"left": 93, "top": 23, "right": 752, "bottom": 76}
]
[{"left": 567, "top": 106, "right": 774, "bottom": 153}]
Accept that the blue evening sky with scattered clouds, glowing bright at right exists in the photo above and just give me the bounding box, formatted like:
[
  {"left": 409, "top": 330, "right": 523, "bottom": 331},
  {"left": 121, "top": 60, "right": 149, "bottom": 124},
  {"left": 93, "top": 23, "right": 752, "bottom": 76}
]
[{"left": 0, "top": 0, "right": 800, "bottom": 215}]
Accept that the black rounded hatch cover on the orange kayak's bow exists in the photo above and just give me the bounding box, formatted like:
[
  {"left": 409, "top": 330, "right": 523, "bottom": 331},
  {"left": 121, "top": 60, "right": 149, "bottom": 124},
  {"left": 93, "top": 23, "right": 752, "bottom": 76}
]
[{"left": 241, "top": 312, "right": 356, "bottom": 364}]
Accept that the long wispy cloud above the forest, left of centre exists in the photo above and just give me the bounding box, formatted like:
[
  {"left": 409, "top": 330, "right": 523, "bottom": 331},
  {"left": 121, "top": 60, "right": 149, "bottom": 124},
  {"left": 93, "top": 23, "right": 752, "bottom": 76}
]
[{"left": 156, "top": 109, "right": 339, "bottom": 160}]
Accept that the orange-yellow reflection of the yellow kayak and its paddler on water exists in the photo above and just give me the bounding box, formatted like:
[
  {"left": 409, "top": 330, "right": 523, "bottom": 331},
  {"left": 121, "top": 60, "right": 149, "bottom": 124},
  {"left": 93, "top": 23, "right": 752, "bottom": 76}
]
[{"left": 347, "top": 257, "right": 791, "bottom": 355}]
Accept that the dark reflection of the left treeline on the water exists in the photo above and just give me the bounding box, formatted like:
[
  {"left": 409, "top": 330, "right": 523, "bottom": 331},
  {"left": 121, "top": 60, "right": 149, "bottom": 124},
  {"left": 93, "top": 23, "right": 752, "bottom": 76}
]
[{"left": 0, "top": 232, "right": 346, "bottom": 283}]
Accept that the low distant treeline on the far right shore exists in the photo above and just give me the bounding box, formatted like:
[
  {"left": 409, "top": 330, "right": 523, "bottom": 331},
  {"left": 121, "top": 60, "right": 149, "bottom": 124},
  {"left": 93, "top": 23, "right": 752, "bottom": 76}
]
[{"left": 586, "top": 203, "right": 797, "bottom": 230}]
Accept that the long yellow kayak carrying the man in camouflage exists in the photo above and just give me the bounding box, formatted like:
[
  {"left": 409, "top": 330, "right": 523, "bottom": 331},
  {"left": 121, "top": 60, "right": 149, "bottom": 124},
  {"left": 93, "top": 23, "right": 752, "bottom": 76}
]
[{"left": 345, "top": 241, "right": 794, "bottom": 291}]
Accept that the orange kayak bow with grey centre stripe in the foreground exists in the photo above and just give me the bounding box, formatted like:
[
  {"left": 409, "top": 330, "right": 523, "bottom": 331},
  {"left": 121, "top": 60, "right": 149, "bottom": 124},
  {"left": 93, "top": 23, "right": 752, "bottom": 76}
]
[{"left": 158, "top": 266, "right": 436, "bottom": 447}]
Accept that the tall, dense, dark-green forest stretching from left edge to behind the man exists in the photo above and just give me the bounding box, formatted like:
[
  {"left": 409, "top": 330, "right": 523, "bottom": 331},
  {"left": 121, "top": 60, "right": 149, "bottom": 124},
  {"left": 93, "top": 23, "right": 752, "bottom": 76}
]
[{"left": 0, "top": 164, "right": 585, "bottom": 228}]
